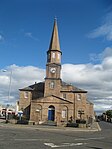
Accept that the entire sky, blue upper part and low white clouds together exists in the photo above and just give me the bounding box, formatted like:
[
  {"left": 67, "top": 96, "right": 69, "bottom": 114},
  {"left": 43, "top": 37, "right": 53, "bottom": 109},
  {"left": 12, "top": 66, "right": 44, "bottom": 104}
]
[{"left": 0, "top": 0, "right": 112, "bottom": 111}]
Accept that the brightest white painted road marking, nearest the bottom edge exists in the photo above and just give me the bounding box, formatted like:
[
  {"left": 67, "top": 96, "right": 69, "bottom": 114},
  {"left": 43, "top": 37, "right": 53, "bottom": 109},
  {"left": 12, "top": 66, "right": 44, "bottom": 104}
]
[{"left": 44, "top": 143, "right": 87, "bottom": 148}]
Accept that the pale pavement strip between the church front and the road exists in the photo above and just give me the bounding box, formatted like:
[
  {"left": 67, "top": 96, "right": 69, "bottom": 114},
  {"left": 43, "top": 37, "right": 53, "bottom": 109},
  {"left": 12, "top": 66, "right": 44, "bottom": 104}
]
[{"left": 0, "top": 119, "right": 101, "bottom": 132}]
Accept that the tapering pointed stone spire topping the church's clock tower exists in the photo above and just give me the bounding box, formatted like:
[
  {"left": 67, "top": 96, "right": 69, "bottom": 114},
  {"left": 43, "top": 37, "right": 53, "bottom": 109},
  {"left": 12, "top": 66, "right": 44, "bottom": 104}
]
[{"left": 49, "top": 18, "right": 60, "bottom": 51}]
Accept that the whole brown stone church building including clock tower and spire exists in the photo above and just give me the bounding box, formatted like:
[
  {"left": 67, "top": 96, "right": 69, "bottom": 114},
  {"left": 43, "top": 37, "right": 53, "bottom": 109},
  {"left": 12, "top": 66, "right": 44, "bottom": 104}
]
[{"left": 19, "top": 19, "right": 94, "bottom": 125}]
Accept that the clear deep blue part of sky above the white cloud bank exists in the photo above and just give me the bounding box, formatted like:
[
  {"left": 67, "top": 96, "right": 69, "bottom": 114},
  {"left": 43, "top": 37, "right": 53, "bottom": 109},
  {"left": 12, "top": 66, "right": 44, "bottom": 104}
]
[{"left": 0, "top": 0, "right": 111, "bottom": 68}]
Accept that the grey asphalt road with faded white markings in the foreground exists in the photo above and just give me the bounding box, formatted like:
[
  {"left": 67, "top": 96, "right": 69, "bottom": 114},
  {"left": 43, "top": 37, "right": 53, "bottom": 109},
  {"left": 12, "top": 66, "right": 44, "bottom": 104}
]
[{"left": 0, "top": 122, "right": 112, "bottom": 149}]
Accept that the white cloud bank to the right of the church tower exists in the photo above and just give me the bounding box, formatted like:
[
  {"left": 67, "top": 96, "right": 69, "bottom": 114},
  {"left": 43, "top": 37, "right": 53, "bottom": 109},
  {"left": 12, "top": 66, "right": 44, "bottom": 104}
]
[{"left": 62, "top": 47, "right": 112, "bottom": 111}]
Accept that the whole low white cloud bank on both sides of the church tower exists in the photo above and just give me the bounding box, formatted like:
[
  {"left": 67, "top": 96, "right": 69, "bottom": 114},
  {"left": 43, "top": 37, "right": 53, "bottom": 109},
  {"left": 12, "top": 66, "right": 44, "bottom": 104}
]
[{"left": 0, "top": 47, "right": 112, "bottom": 111}]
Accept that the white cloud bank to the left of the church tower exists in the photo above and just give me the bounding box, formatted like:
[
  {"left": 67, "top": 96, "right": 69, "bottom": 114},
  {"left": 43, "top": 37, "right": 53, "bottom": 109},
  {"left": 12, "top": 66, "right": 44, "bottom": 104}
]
[{"left": 0, "top": 65, "right": 45, "bottom": 104}]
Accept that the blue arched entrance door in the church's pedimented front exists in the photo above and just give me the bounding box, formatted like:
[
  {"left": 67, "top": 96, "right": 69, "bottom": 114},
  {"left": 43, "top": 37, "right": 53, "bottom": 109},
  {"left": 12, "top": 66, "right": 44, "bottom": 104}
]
[{"left": 48, "top": 105, "right": 55, "bottom": 121}]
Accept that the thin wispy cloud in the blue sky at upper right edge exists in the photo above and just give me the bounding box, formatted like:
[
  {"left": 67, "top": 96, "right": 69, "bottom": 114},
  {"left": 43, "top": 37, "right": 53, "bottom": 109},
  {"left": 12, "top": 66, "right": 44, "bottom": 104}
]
[{"left": 88, "top": 12, "right": 112, "bottom": 41}]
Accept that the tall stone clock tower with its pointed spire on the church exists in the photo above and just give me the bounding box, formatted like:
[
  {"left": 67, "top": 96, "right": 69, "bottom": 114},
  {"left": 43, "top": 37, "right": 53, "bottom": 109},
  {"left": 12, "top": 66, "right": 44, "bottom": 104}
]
[{"left": 44, "top": 19, "right": 62, "bottom": 96}]
